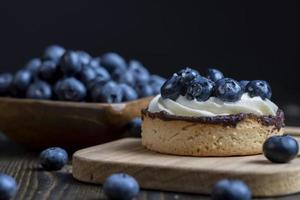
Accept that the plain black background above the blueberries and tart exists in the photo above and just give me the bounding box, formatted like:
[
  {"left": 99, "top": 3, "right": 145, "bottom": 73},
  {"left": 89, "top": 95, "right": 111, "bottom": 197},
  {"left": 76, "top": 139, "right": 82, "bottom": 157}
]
[{"left": 0, "top": 0, "right": 300, "bottom": 112}]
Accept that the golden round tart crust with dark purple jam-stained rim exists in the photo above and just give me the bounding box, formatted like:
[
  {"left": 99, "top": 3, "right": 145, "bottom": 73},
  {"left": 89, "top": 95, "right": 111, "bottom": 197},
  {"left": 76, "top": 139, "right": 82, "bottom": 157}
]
[{"left": 142, "top": 109, "right": 284, "bottom": 156}]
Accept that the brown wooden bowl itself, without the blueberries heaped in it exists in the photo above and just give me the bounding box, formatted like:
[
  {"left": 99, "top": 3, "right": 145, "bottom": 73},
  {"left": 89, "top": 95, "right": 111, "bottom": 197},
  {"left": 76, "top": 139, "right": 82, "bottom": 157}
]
[{"left": 0, "top": 97, "right": 152, "bottom": 150}]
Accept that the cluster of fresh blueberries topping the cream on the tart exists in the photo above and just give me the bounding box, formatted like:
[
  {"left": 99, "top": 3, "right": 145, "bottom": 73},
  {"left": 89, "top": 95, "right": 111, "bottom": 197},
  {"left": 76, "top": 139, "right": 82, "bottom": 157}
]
[{"left": 161, "top": 68, "right": 272, "bottom": 102}]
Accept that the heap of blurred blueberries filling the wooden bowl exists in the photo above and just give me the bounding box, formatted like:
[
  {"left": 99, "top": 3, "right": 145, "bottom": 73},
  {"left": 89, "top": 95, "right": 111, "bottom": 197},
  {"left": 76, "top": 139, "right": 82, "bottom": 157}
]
[{"left": 0, "top": 45, "right": 165, "bottom": 103}]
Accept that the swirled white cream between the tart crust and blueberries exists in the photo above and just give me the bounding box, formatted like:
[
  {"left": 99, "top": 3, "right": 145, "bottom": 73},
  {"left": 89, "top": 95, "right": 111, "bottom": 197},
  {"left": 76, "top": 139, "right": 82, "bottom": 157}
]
[{"left": 148, "top": 93, "right": 278, "bottom": 117}]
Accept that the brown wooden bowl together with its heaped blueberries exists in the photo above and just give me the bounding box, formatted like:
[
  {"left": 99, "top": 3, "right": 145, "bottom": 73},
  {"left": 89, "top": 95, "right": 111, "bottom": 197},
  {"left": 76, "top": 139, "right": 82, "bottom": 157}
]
[{"left": 0, "top": 44, "right": 164, "bottom": 150}]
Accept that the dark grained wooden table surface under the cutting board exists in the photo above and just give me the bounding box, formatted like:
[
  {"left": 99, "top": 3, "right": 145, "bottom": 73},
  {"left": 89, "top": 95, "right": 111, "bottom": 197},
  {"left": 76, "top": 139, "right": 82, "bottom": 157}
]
[{"left": 0, "top": 134, "right": 300, "bottom": 200}]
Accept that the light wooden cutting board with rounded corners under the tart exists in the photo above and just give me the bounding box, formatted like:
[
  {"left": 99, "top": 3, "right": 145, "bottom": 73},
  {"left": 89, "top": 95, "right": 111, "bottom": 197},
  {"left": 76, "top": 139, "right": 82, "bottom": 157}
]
[{"left": 73, "top": 139, "right": 300, "bottom": 197}]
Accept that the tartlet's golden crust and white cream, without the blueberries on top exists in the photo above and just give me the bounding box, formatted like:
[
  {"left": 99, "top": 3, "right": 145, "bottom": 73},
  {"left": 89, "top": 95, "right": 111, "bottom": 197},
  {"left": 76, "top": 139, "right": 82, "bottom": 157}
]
[{"left": 142, "top": 68, "right": 284, "bottom": 156}]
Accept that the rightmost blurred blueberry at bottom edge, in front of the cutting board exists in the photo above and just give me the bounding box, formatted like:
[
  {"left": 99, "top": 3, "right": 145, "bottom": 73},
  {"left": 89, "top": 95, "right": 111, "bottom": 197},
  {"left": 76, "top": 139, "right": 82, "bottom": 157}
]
[{"left": 212, "top": 179, "right": 252, "bottom": 200}]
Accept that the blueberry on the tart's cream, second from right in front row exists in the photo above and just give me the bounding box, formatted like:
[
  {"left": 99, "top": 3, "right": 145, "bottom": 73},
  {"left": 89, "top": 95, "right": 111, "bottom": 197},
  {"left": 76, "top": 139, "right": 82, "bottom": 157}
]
[{"left": 215, "top": 78, "right": 243, "bottom": 102}]
